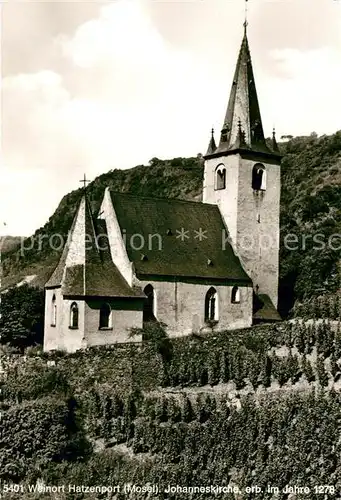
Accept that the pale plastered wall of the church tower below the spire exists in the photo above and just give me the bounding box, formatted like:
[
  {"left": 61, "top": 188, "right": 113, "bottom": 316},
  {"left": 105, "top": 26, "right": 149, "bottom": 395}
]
[{"left": 203, "top": 154, "right": 281, "bottom": 307}]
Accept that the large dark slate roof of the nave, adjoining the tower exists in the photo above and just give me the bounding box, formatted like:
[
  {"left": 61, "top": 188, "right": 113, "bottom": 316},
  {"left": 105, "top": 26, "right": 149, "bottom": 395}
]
[{"left": 111, "top": 191, "right": 251, "bottom": 285}]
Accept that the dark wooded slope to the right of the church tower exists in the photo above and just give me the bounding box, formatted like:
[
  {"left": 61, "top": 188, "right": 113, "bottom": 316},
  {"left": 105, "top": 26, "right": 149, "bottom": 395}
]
[{"left": 280, "top": 131, "right": 341, "bottom": 309}]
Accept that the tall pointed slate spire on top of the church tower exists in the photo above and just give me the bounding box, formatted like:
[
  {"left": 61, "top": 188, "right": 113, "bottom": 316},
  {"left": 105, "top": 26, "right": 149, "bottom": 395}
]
[{"left": 218, "top": 23, "right": 267, "bottom": 151}]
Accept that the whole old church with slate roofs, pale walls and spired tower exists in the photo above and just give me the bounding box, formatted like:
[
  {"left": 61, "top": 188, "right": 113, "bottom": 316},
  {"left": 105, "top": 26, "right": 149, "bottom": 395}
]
[{"left": 44, "top": 23, "right": 281, "bottom": 352}]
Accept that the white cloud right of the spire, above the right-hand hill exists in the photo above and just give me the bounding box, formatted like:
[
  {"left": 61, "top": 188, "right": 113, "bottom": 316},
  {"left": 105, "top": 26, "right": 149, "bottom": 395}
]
[{"left": 263, "top": 47, "right": 341, "bottom": 135}]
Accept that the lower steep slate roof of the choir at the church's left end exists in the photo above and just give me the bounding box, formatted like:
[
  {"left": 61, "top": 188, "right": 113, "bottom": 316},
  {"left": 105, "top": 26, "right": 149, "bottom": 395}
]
[{"left": 45, "top": 194, "right": 145, "bottom": 298}]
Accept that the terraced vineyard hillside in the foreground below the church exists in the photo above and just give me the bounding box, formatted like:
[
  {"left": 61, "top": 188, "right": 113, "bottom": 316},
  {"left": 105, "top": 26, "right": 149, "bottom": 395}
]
[{"left": 0, "top": 322, "right": 341, "bottom": 500}]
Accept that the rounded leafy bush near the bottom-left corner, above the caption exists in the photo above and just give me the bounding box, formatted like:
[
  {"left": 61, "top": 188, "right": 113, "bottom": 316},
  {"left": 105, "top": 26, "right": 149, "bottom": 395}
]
[{"left": 0, "top": 398, "right": 90, "bottom": 482}]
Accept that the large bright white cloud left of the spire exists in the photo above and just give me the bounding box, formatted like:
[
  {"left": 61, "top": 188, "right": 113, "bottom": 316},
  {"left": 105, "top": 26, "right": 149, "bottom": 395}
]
[{"left": 2, "top": 0, "right": 211, "bottom": 234}]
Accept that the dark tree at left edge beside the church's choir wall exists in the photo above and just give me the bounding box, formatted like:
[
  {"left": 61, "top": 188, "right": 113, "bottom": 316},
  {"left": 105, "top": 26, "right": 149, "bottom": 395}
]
[{"left": 0, "top": 284, "right": 44, "bottom": 349}]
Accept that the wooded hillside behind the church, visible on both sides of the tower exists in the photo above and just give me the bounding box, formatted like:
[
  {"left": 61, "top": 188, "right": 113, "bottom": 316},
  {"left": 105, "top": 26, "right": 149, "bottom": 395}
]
[{"left": 4, "top": 132, "right": 341, "bottom": 316}]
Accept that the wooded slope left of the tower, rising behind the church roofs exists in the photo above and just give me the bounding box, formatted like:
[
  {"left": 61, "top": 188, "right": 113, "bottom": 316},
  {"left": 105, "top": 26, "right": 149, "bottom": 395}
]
[{"left": 3, "top": 157, "right": 203, "bottom": 286}]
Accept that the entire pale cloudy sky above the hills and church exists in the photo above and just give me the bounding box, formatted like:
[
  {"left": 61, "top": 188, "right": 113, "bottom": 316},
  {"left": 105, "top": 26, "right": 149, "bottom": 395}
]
[{"left": 0, "top": 0, "right": 341, "bottom": 236}]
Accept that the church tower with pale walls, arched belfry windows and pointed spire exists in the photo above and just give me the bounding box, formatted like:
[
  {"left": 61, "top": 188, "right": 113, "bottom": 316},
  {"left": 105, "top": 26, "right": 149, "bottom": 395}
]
[{"left": 203, "top": 22, "right": 281, "bottom": 307}]
